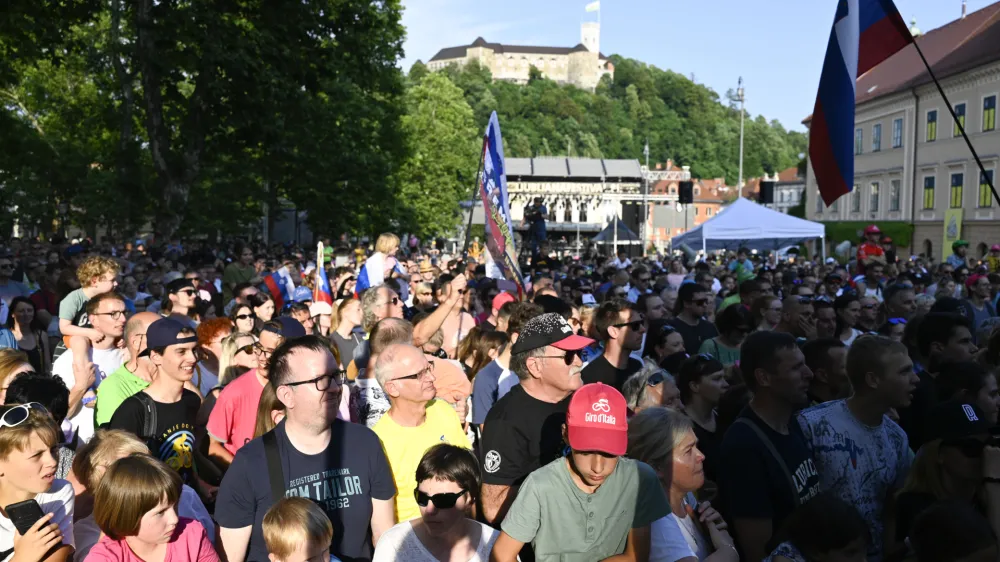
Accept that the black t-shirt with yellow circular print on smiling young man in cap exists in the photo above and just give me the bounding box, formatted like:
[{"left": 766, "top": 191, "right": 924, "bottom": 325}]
[{"left": 109, "top": 388, "right": 201, "bottom": 486}]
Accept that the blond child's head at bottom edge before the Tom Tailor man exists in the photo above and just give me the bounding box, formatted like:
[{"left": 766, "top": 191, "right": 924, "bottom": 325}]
[{"left": 262, "top": 498, "right": 340, "bottom": 562}]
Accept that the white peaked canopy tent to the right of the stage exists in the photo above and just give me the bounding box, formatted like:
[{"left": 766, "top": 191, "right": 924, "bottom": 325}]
[{"left": 670, "top": 197, "right": 826, "bottom": 258}]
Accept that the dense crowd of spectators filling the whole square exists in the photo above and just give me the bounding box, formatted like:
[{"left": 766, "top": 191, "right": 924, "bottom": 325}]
[{"left": 0, "top": 226, "right": 1000, "bottom": 562}]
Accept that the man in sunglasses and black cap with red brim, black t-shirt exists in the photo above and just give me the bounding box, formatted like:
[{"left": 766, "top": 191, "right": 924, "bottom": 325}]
[{"left": 481, "top": 313, "right": 594, "bottom": 524}]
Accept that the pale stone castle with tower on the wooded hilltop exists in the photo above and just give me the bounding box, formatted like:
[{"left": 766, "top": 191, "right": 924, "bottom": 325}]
[{"left": 427, "top": 22, "right": 615, "bottom": 91}]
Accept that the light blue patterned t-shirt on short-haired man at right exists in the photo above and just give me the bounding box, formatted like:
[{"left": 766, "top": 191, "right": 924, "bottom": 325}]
[{"left": 798, "top": 400, "right": 913, "bottom": 562}]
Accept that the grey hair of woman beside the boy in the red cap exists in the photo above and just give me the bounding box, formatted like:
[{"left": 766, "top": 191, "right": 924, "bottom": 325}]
[{"left": 626, "top": 406, "right": 693, "bottom": 474}]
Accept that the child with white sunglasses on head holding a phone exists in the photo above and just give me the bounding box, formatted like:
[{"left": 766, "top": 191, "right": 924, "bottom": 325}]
[{"left": 0, "top": 402, "right": 74, "bottom": 562}]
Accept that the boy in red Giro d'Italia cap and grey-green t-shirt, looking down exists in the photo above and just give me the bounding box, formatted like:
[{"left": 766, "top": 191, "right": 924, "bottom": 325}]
[{"left": 487, "top": 383, "right": 670, "bottom": 562}]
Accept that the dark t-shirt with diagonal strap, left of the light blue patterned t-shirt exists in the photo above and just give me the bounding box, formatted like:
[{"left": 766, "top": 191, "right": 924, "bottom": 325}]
[{"left": 717, "top": 406, "right": 820, "bottom": 530}]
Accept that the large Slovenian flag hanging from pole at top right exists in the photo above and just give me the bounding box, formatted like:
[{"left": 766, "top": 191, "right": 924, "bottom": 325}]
[{"left": 809, "top": 0, "right": 913, "bottom": 206}]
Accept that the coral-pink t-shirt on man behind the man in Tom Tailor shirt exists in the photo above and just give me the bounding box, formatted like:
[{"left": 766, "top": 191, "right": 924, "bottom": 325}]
[{"left": 207, "top": 369, "right": 264, "bottom": 455}]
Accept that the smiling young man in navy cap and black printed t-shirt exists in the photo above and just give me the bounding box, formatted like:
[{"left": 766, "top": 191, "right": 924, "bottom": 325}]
[{"left": 110, "top": 318, "right": 205, "bottom": 499}]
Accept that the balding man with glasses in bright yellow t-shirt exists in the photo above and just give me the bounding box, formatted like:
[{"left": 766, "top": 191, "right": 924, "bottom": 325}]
[{"left": 372, "top": 344, "right": 469, "bottom": 522}]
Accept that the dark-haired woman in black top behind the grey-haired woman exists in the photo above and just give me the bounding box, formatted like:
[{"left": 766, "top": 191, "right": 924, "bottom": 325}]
[{"left": 677, "top": 355, "right": 729, "bottom": 482}]
